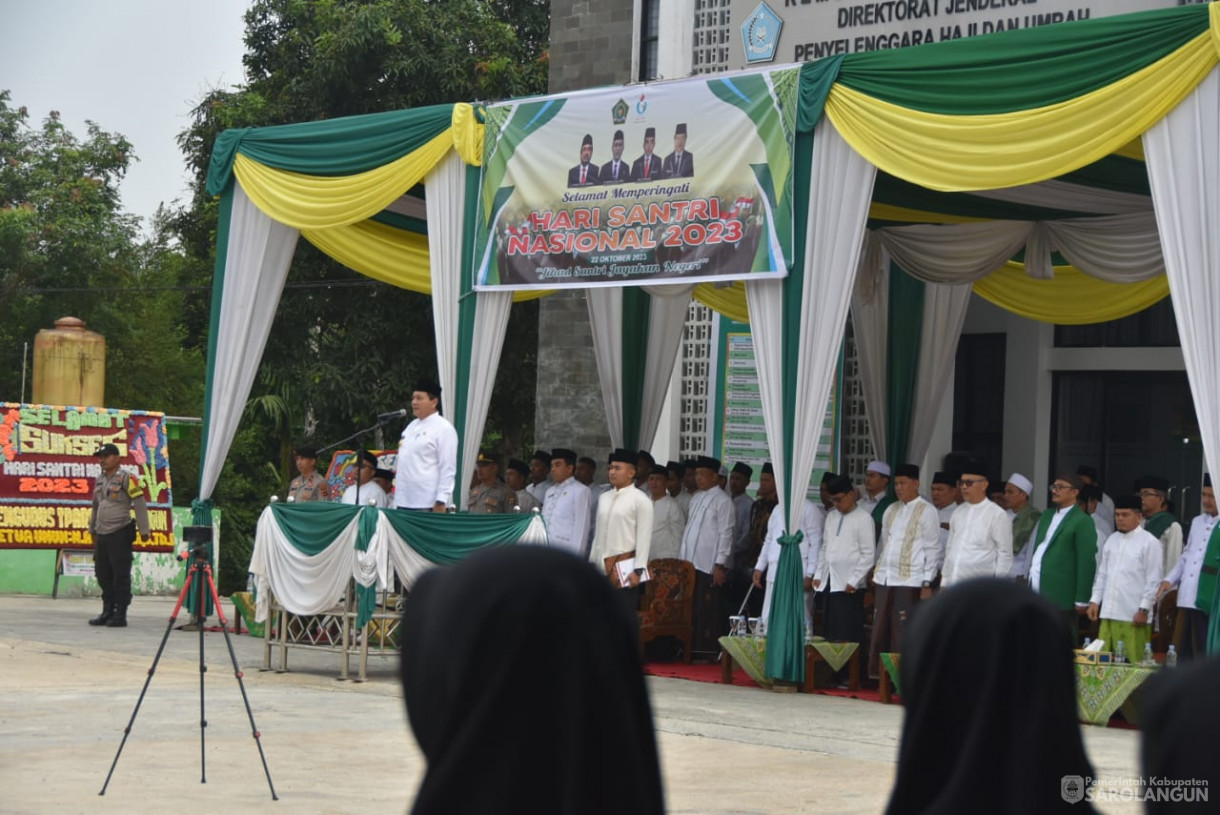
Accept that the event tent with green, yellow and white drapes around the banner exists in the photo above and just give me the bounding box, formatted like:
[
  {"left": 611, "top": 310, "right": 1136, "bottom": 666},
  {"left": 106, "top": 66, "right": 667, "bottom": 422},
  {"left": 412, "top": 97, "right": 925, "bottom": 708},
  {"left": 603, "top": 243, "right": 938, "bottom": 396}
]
[{"left": 200, "top": 2, "right": 1220, "bottom": 678}]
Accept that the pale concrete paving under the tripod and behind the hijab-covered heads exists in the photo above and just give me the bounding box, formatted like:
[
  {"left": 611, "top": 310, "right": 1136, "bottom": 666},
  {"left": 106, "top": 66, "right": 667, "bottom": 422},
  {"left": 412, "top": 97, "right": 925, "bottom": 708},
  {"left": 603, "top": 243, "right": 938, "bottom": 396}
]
[{"left": 0, "top": 597, "right": 1139, "bottom": 815}]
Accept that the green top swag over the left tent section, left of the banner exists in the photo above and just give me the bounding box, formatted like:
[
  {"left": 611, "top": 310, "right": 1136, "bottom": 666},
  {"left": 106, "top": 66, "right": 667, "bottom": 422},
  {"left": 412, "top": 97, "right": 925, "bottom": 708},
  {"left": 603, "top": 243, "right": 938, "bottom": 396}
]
[{"left": 207, "top": 105, "right": 454, "bottom": 195}]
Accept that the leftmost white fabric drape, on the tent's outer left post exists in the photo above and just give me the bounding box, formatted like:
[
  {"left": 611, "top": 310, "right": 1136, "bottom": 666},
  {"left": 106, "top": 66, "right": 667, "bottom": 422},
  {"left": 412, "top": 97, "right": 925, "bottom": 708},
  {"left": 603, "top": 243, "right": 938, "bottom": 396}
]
[{"left": 199, "top": 179, "right": 300, "bottom": 500}]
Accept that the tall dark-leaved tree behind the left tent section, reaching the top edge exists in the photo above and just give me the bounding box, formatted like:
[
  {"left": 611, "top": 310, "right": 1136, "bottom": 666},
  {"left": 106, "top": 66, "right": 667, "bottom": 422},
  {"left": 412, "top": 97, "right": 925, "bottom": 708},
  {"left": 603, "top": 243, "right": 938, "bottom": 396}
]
[{"left": 172, "top": 0, "right": 549, "bottom": 541}]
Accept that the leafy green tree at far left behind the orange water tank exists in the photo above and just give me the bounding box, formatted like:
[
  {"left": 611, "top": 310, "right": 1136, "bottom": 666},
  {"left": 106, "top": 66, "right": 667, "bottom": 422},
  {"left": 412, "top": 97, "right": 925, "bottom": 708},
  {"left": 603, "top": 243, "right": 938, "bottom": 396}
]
[{"left": 0, "top": 92, "right": 204, "bottom": 414}]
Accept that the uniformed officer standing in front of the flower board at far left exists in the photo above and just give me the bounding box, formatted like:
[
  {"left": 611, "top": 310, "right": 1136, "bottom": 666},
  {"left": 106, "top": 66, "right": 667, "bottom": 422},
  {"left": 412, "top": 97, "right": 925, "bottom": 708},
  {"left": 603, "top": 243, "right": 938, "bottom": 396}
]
[{"left": 89, "top": 444, "right": 149, "bottom": 628}]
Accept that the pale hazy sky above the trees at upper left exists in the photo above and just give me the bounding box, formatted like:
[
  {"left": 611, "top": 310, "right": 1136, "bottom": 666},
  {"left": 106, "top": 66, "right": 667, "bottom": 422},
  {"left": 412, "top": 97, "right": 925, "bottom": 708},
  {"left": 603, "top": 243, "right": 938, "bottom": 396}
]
[{"left": 0, "top": 0, "right": 249, "bottom": 229}]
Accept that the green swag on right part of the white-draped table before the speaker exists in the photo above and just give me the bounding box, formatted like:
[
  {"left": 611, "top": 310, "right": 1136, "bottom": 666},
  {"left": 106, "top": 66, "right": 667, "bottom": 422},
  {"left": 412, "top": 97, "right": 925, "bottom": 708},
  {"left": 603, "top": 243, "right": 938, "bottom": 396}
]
[{"left": 382, "top": 510, "right": 532, "bottom": 565}]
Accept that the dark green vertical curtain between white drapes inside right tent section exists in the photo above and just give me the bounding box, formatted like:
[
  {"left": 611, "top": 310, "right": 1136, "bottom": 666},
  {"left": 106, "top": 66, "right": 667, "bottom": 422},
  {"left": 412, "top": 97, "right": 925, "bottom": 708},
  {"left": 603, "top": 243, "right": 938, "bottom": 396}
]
[{"left": 886, "top": 264, "right": 924, "bottom": 470}]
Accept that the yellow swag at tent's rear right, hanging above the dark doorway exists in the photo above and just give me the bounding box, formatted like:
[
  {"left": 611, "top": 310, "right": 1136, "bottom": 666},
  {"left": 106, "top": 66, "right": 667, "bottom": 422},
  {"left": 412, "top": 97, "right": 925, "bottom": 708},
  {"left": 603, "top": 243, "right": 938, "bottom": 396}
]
[{"left": 974, "top": 262, "right": 1169, "bottom": 326}]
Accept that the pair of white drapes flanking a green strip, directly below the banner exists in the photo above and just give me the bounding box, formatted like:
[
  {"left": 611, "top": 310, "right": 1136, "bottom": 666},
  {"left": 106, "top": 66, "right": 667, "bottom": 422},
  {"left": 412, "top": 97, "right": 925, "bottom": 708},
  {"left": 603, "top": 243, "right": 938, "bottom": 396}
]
[{"left": 584, "top": 285, "right": 694, "bottom": 450}]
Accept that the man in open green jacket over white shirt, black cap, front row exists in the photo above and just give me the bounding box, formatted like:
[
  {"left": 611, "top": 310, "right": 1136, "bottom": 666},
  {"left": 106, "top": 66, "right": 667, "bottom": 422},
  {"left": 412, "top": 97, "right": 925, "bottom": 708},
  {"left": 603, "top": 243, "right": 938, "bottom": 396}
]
[{"left": 1026, "top": 473, "right": 1097, "bottom": 641}]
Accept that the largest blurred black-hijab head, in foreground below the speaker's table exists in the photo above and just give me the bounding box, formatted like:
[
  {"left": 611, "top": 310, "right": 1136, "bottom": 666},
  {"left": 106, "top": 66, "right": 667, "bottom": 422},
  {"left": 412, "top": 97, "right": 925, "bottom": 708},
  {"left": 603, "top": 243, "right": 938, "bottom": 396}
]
[{"left": 400, "top": 547, "right": 665, "bottom": 815}]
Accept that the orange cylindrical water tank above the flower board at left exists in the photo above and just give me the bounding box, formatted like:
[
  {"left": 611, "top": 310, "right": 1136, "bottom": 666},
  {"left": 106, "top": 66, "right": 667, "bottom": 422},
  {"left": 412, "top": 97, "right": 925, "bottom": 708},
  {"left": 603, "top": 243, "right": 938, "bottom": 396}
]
[{"left": 33, "top": 317, "right": 106, "bottom": 408}]
